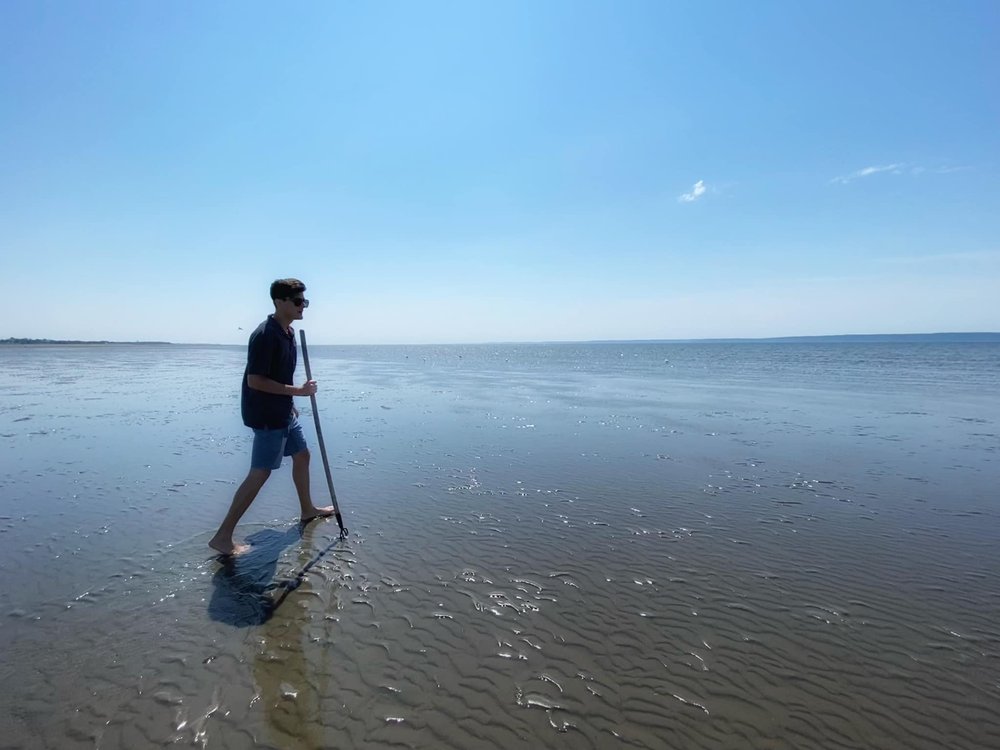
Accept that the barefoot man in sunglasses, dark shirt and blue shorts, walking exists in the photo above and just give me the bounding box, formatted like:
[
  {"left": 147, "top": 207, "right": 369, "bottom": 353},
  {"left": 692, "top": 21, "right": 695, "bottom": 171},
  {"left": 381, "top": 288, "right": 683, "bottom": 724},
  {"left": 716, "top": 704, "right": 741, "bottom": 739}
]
[{"left": 208, "top": 279, "right": 334, "bottom": 555}]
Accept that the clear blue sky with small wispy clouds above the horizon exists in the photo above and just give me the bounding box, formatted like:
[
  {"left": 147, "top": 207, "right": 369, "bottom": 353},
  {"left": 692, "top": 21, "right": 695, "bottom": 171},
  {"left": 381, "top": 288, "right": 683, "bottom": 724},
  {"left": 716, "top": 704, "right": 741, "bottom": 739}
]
[{"left": 0, "top": 0, "right": 1000, "bottom": 344}]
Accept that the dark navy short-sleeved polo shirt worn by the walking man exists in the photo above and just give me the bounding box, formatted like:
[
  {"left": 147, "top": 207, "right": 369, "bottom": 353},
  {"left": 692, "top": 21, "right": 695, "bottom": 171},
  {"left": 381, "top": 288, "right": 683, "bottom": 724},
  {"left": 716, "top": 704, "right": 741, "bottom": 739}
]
[{"left": 240, "top": 315, "right": 298, "bottom": 430}]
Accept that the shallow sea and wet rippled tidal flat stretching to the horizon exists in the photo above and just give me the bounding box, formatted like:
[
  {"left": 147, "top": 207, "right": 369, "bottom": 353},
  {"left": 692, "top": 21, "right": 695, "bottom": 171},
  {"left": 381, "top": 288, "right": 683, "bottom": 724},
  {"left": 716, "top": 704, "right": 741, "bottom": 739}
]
[{"left": 0, "top": 342, "right": 1000, "bottom": 750}]
